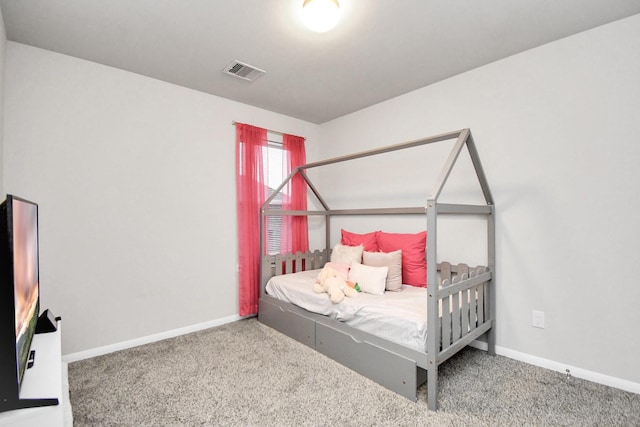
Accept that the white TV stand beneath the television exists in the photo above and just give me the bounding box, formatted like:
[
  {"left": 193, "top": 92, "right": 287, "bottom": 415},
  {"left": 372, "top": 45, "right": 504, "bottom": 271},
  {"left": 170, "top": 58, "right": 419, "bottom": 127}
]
[{"left": 0, "top": 321, "right": 73, "bottom": 427}]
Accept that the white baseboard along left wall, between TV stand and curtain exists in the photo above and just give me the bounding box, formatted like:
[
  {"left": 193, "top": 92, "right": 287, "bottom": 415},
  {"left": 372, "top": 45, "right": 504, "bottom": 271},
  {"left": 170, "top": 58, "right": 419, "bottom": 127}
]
[{"left": 62, "top": 315, "right": 243, "bottom": 363}]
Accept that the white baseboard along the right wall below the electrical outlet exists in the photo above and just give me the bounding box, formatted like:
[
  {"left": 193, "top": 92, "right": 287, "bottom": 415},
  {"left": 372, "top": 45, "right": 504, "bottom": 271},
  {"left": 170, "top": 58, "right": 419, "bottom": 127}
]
[{"left": 470, "top": 340, "right": 640, "bottom": 394}]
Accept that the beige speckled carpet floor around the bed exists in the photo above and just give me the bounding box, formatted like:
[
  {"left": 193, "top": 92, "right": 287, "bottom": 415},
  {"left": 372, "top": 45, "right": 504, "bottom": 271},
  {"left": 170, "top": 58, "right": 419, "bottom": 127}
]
[{"left": 69, "top": 318, "right": 640, "bottom": 427}]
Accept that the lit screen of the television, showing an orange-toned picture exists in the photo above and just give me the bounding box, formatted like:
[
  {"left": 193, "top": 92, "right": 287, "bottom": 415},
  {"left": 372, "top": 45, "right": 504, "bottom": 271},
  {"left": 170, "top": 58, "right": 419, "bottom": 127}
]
[{"left": 7, "top": 197, "right": 40, "bottom": 384}]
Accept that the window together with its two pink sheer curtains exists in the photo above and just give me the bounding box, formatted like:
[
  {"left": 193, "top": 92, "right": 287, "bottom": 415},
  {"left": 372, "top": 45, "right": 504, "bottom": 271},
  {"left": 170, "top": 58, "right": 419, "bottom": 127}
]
[{"left": 235, "top": 123, "right": 309, "bottom": 316}]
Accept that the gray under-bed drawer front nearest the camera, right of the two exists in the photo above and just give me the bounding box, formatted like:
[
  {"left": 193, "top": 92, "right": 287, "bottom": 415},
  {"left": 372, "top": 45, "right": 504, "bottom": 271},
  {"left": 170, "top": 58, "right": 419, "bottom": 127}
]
[{"left": 316, "top": 322, "right": 418, "bottom": 401}]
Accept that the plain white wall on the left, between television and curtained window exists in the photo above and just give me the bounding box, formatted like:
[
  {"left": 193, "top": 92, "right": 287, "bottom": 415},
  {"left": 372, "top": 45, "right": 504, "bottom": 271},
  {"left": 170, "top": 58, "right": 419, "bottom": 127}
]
[{"left": 4, "top": 42, "right": 319, "bottom": 354}]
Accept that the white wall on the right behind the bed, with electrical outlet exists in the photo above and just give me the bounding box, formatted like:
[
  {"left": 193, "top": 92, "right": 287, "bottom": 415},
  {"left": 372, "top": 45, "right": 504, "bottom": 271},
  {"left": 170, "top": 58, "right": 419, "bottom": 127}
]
[{"left": 321, "top": 15, "right": 640, "bottom": 383}]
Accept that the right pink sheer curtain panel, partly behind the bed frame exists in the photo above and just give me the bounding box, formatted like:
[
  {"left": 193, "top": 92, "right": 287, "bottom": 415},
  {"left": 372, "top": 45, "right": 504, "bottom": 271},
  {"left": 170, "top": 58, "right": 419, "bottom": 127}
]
[{"left": 280, "top": 134, "right": 309, "bottom": 253}]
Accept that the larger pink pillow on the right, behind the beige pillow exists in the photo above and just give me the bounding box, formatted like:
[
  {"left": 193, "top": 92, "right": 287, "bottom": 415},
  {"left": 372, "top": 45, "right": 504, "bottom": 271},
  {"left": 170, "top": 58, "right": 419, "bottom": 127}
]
[{"left": 377, "top": 231, "right": 427, "bottom": 288}]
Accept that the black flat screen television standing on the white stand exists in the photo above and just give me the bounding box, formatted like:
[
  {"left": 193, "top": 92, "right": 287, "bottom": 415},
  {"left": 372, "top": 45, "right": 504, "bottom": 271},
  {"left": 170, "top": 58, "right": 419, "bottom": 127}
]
[{"left": 0, "top": 195, "right": 58, "bottom": 412}]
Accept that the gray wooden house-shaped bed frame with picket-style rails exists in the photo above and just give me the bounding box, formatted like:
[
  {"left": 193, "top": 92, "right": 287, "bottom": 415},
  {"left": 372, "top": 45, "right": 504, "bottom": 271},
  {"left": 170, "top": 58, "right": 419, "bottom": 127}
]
[{"left": 258, "top": 129, "right": 495, "bottom": 410}]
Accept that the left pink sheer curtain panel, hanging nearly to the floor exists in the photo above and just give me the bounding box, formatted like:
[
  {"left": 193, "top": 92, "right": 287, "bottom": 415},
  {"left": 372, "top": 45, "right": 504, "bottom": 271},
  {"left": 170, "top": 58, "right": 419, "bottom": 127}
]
[{"left": 236, "top": 123, "right": 267, "bottom": 316}]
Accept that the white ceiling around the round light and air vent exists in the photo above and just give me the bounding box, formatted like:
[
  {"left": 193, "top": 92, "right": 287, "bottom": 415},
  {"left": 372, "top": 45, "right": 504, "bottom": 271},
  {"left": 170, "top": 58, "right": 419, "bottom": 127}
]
[{"left": 0, "top": 0, "right": 640, "bottom": 123}]
